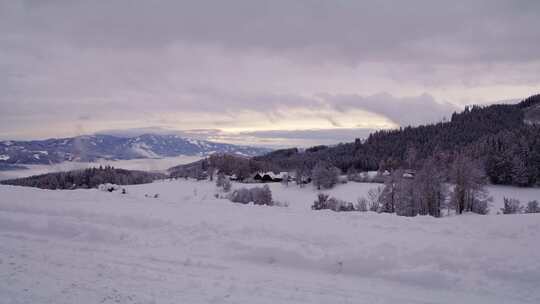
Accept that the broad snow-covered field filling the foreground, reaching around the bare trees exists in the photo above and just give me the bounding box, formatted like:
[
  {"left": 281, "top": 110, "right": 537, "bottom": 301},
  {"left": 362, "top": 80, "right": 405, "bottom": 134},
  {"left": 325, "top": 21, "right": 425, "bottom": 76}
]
[{"left": 0, "top": 180, "right": 540, "bottom": 304}]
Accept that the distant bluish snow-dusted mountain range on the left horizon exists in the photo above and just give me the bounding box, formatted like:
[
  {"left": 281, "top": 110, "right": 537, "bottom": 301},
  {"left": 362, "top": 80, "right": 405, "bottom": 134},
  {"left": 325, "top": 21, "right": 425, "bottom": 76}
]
[{"left": 0, "top": 134, "right": 270, "bottom": 169}]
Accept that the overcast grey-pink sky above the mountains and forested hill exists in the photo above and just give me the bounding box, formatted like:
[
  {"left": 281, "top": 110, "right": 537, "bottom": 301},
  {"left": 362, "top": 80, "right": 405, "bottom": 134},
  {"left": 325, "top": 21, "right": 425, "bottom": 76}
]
[{"left": 0, "top": 0, "right": 540, "bottom": 146}]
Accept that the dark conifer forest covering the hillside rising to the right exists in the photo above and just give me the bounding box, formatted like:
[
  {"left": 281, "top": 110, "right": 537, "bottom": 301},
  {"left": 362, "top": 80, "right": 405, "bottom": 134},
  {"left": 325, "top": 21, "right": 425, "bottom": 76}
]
[{"left": 253, "top": 95, "right": 540, "bottom": 186}]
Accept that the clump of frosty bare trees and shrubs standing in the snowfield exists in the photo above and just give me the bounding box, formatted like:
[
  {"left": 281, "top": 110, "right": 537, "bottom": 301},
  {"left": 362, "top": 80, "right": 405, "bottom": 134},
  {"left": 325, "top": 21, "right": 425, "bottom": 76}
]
[{"left": 312, "top": 154, "right": 491, "bottom": 217}]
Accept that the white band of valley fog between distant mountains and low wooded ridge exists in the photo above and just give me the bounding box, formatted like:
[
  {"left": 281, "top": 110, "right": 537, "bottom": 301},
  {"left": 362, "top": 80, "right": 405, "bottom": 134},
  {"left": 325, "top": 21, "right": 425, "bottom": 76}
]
[{"left": 0, "top": 155, "right": 201, "bottom": 180}]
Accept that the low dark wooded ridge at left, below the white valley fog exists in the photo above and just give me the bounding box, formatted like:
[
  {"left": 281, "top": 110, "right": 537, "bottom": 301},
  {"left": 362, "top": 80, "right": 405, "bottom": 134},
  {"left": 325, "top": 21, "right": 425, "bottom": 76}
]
[{"left": 0, "top": 166, "right": 166, "bottom": 190}]
